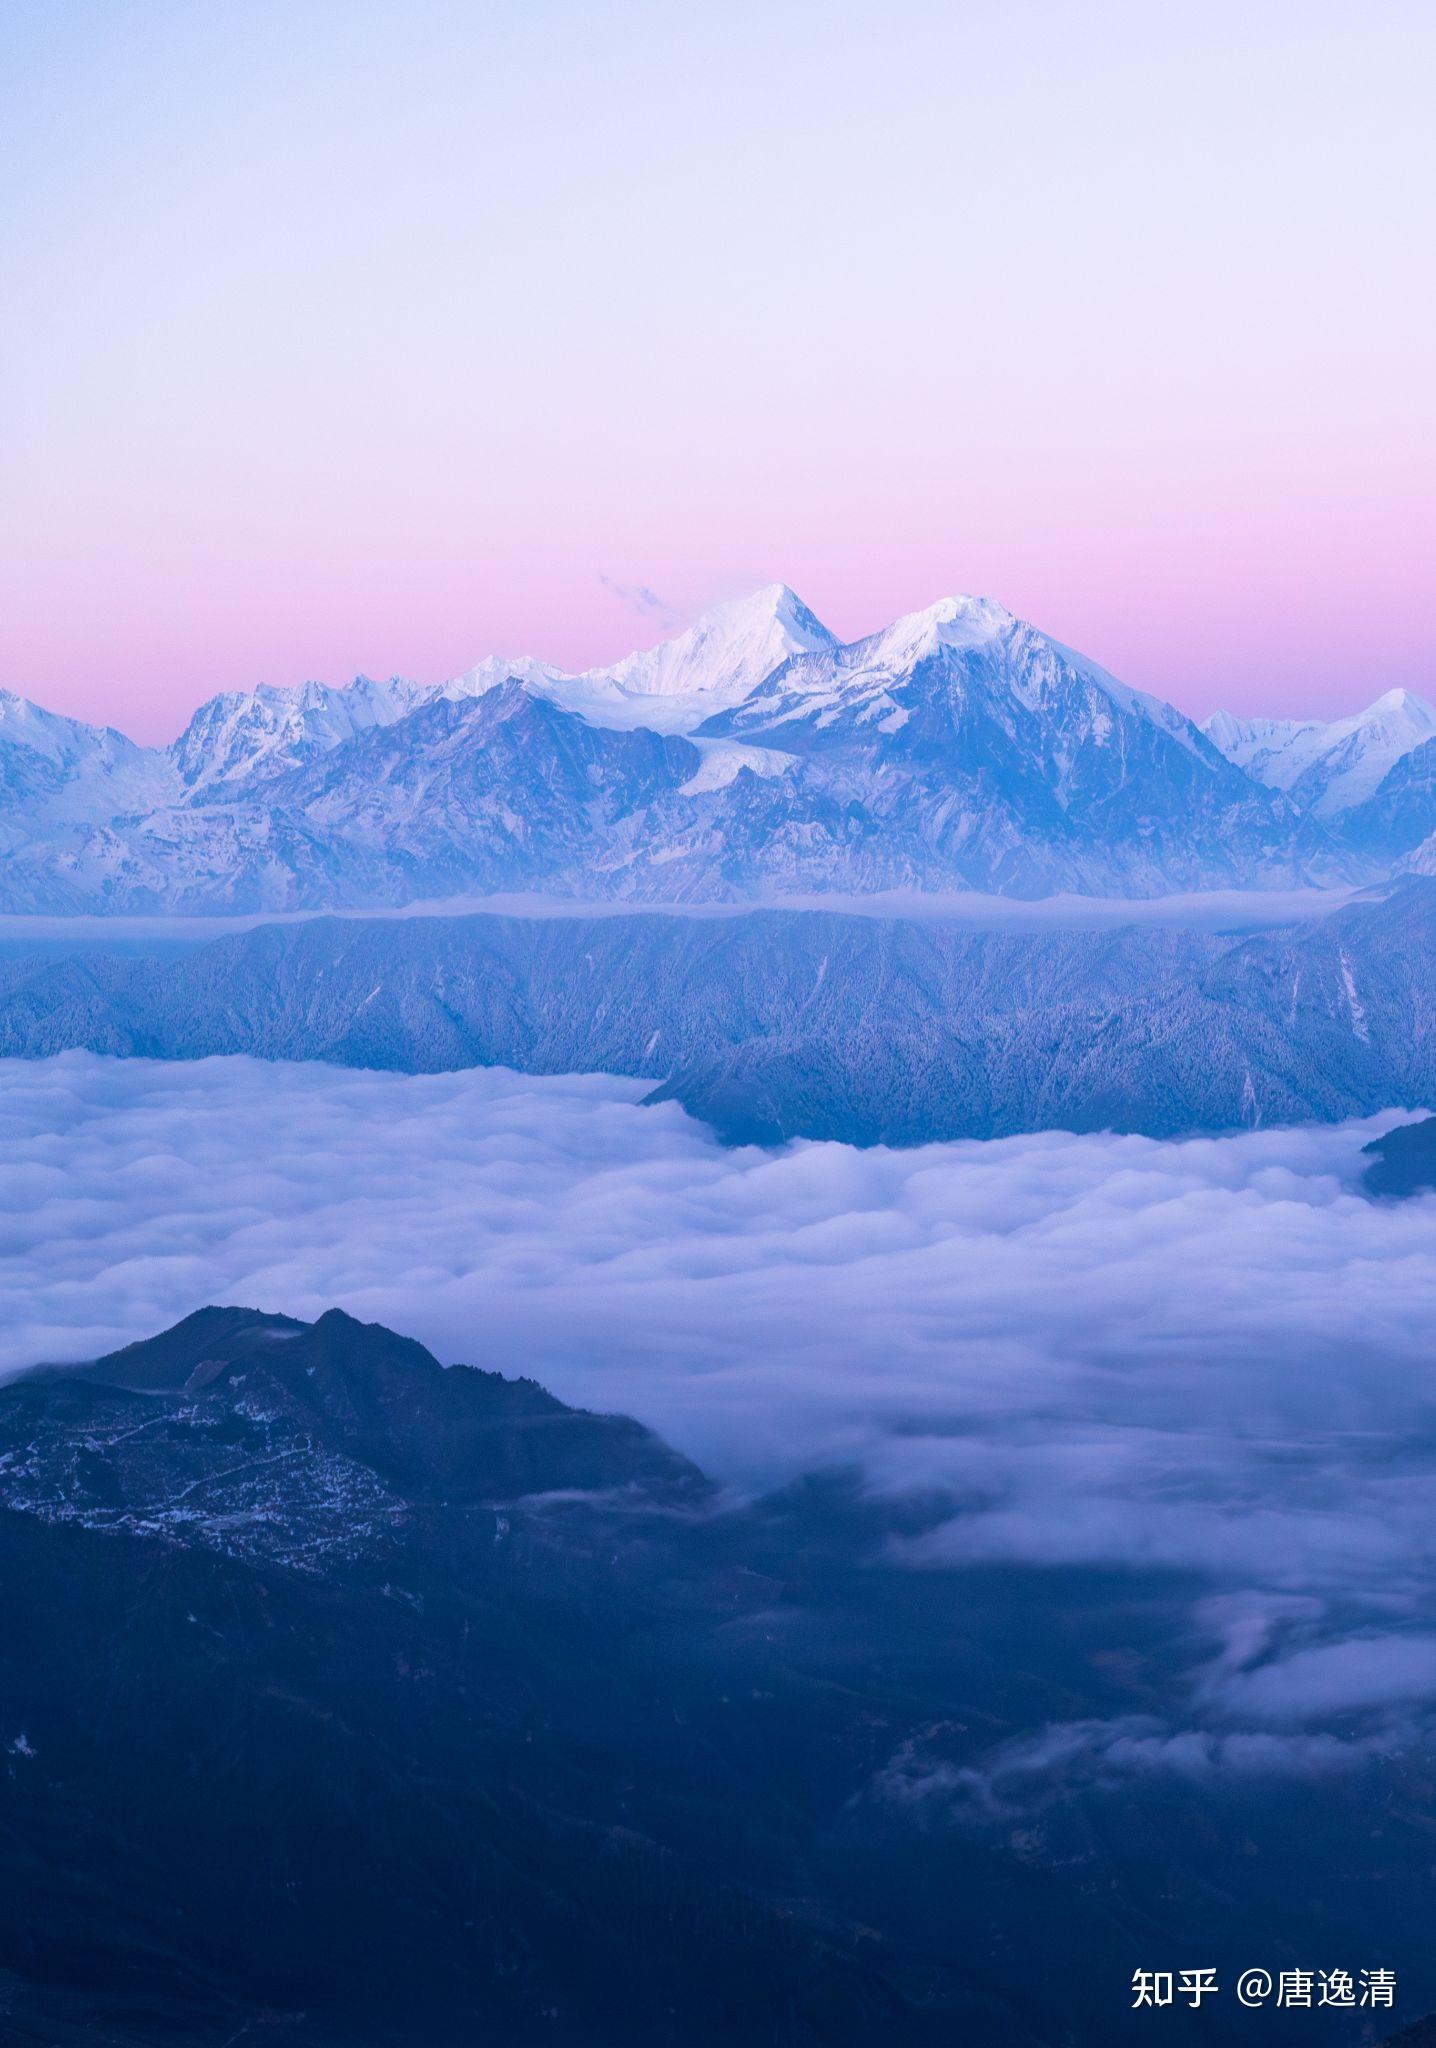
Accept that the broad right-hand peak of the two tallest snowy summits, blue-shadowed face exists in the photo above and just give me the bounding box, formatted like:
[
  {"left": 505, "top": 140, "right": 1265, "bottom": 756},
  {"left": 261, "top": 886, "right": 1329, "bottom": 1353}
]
[{"left": 701, "top": 598, "right": 1321, "bottom": 895}]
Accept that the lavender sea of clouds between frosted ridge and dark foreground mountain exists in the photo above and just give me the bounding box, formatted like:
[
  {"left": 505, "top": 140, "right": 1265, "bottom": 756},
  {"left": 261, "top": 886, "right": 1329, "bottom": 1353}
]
[{"left": 0, "top": 1055, "right": 1436, "bottom": 1804}]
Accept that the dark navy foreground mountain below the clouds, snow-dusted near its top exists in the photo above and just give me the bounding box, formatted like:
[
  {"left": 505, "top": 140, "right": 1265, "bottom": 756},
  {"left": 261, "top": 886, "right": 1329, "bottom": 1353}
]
[{"left": 0, "top": 1309, "right": 1436, "bottom": 2048}]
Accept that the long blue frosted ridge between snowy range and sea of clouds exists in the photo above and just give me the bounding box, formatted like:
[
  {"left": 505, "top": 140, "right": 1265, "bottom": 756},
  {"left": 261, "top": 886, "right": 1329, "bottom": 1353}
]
[{"left": 0, "top": 877, "right": 1436, "bottom": 1145}]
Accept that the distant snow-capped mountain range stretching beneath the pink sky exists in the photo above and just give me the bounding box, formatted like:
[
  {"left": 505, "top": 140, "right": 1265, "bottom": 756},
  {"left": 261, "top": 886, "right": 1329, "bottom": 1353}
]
[{"left": 0, "top": 586, "right": 1436, "bottom": 911}]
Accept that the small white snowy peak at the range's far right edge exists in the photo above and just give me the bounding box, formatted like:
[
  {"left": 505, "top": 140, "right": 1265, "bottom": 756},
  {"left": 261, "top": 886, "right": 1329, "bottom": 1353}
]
[{"left": 1202, "top": 690, "right": 1436, "bottom": 819}]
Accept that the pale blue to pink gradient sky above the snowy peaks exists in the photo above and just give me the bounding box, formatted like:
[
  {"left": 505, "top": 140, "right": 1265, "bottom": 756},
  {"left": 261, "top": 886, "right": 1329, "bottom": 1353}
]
[{"left": 0, "top": 0, "right": 1436, "bottom": 739}]
